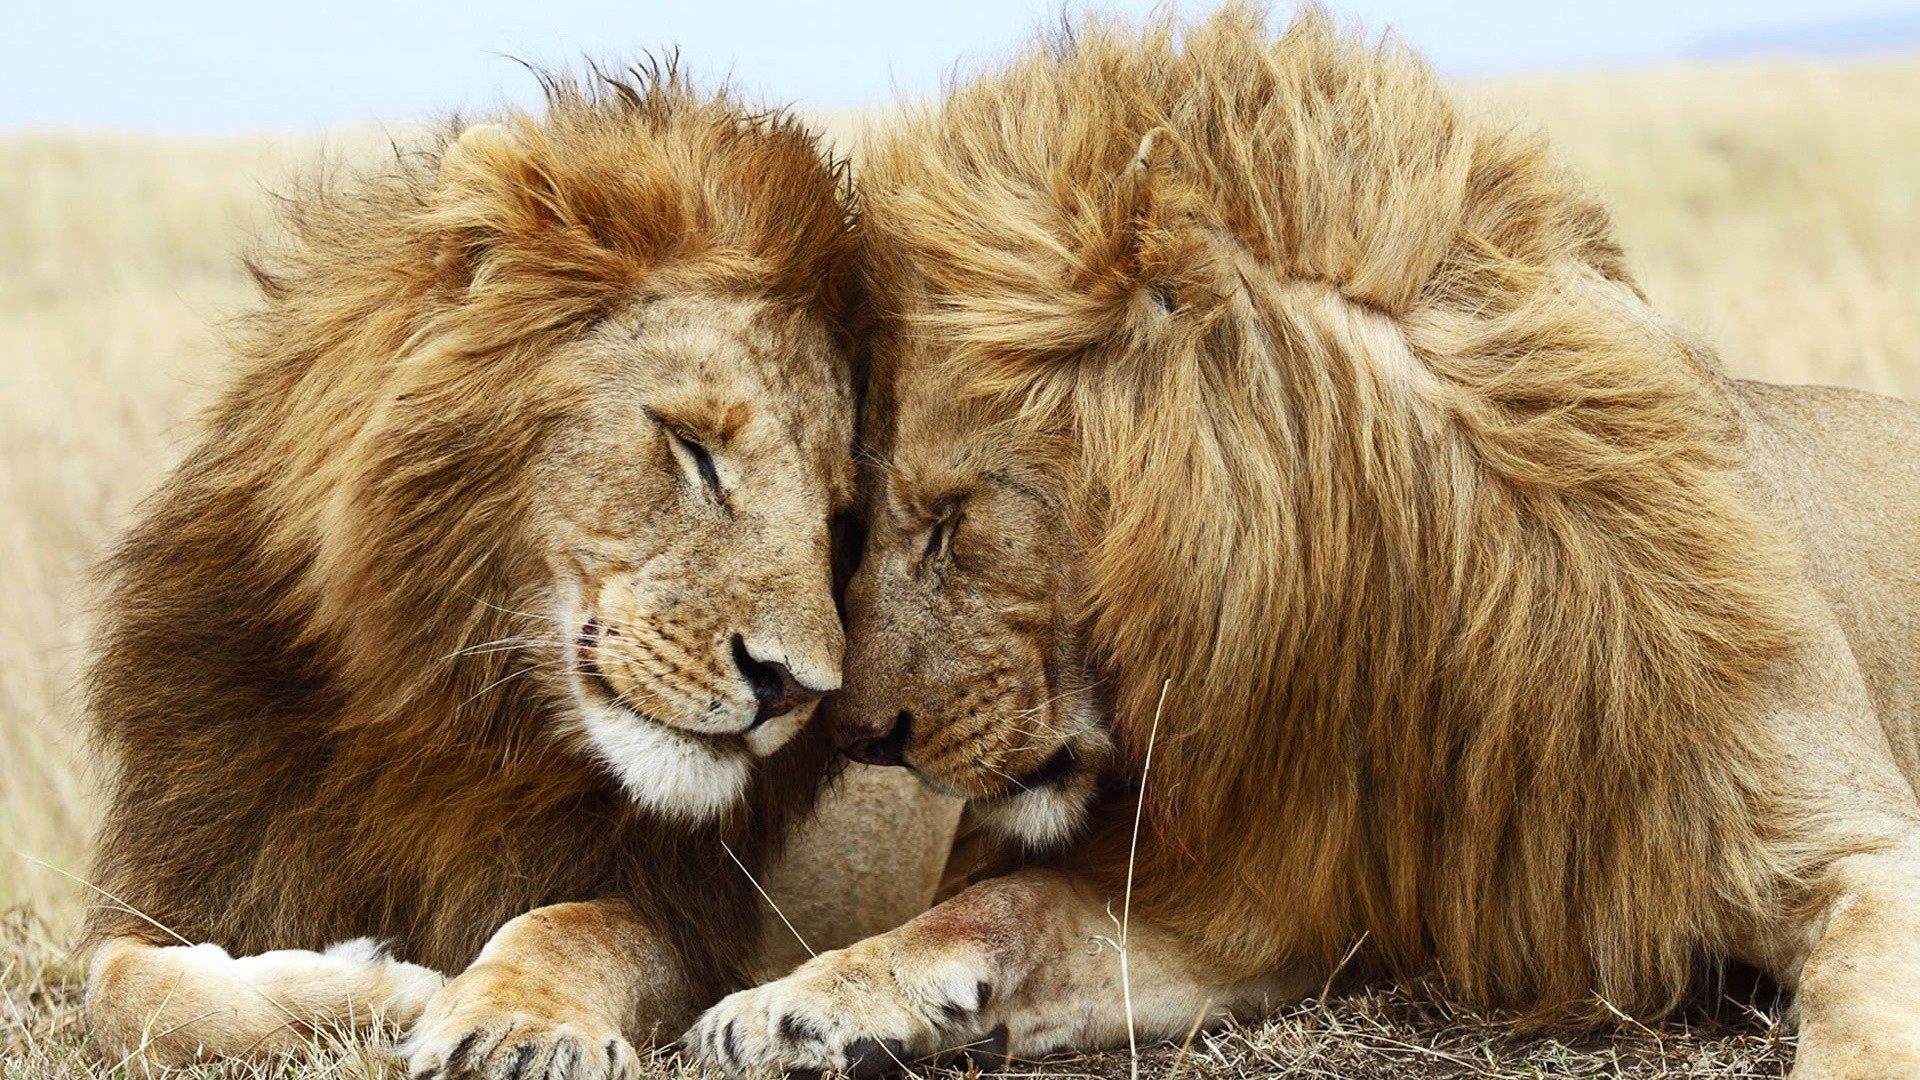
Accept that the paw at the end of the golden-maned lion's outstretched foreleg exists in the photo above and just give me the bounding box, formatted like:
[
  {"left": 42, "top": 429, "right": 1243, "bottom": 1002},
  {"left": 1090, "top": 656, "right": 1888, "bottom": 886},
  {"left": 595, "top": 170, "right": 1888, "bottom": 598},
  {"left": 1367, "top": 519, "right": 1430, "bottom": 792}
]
[{"left": 682, "top": 953, "right": 993, "bottom": 1076}]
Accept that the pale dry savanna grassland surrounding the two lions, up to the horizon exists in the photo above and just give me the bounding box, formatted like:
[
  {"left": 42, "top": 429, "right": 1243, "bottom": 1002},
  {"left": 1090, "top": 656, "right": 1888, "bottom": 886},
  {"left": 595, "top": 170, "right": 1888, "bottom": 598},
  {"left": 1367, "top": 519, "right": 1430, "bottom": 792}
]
[{"left": 0, "top": 58, "right": 1920, "bottom": 1080}]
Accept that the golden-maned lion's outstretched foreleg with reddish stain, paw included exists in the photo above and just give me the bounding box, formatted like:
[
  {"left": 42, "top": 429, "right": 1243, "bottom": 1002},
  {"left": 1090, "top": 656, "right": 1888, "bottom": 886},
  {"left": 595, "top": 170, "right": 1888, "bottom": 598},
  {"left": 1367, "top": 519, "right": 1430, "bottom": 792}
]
[{"left": 685, "top": 871, "right": 1292, "bottom": 1074}]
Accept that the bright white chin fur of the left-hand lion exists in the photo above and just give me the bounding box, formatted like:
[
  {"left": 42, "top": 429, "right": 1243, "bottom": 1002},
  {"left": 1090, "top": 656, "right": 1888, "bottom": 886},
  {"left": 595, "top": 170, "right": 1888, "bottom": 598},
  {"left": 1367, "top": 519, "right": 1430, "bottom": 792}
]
[{"left": 580, "top": 705, "right": 753, "bottom": 821}]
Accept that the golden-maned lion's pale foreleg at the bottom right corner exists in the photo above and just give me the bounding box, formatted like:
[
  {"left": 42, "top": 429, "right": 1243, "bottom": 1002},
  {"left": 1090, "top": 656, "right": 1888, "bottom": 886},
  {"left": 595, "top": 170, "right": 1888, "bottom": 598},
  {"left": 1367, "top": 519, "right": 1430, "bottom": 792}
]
[{"left": 1793, "top": 836, "right": 1920, "bottom": 1080}]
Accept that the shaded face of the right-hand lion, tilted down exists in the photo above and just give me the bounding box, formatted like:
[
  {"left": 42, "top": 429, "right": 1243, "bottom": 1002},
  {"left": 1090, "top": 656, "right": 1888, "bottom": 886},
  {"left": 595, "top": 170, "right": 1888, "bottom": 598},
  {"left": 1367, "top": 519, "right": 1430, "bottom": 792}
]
[{"left": 835, "top": 395, "right": 1110, "bottom": 846}]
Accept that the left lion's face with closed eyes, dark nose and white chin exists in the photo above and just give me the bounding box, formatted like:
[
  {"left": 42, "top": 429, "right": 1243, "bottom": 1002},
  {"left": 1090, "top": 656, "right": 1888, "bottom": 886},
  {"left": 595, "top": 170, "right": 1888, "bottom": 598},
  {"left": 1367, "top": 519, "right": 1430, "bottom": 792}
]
[{"left": 532, "top": 288, "right": 852, "bottom": 819}]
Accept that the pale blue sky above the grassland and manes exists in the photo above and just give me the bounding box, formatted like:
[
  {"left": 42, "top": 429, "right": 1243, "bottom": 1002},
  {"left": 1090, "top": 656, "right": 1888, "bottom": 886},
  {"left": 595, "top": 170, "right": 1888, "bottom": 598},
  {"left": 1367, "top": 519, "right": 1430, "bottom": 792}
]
[{"left": 11, "top": 0, "right": 1914, "bottom": 133}]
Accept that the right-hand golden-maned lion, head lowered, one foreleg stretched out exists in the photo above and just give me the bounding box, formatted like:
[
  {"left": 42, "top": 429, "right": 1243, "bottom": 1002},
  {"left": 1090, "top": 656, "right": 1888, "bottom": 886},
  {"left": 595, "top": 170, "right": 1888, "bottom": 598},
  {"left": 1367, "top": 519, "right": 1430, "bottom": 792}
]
[{"left": 685, "top": 6, "right": 1920, "bottom": 1078}]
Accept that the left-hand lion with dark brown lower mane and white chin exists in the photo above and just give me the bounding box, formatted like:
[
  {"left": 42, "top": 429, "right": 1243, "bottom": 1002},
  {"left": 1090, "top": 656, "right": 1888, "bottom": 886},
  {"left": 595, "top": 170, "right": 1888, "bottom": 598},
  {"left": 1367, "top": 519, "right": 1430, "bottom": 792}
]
[{"left": 84, "top": 67, "right": 960, "bottom": 1078}]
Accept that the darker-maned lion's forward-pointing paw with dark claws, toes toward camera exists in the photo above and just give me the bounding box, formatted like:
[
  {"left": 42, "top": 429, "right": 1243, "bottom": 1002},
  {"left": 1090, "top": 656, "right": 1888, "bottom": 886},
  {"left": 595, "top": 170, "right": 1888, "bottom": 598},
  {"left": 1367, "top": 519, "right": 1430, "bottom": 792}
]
[{"left": 401, "top": 969, "right": 639, "bottom": 1080}]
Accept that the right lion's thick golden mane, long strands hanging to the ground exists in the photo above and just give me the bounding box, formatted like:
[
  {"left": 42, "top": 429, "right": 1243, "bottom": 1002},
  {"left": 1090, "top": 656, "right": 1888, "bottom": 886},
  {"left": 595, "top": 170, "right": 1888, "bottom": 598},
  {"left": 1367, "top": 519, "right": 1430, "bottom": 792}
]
[{"left": 862, "top": 8, "right": 1793, "bottom": 1013}]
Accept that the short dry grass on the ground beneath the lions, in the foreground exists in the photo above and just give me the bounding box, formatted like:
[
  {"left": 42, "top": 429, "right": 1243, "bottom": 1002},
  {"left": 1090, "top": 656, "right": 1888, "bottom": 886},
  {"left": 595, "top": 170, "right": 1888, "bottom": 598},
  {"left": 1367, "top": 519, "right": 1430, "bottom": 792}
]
[{"left": 0, "top": 907, "right": 1793, "bottom": 1080}]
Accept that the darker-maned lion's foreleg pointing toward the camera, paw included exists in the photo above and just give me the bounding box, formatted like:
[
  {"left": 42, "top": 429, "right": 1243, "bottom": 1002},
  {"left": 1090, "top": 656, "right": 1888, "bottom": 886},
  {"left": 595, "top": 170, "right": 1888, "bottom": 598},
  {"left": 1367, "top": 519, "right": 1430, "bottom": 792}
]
[{"left": 403, "top": 899, "right": 691, "bottom": 1080}]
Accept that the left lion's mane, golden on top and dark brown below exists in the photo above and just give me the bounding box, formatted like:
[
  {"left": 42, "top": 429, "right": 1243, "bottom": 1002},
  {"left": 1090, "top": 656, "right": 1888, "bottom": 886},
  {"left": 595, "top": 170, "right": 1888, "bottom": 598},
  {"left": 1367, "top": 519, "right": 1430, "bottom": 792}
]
[{"left": 86, "top": 69, "right": 856, "bottom": 999}]
